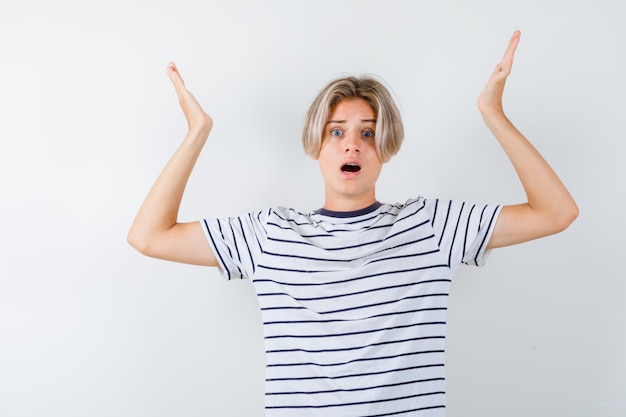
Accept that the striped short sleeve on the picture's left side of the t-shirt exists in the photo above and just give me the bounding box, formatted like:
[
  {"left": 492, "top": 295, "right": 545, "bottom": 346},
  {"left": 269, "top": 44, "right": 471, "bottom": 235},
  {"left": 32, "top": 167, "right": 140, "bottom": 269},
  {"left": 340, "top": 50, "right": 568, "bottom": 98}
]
[{"left": 201, "top": 212, "right": 267, "bottom": 280}]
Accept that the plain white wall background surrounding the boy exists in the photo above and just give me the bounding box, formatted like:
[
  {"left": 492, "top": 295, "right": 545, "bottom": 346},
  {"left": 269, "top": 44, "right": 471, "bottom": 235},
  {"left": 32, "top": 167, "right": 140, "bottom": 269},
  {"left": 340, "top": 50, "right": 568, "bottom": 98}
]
[{"left": 0, "top": 0, "right": 626, "bottom": 417}]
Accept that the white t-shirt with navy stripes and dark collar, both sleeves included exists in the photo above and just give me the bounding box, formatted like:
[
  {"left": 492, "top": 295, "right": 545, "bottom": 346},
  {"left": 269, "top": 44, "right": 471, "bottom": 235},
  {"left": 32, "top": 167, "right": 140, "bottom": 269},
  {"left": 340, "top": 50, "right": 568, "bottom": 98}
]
[{"left": 203, "top": 197, "right": 500, "bottom": 417}]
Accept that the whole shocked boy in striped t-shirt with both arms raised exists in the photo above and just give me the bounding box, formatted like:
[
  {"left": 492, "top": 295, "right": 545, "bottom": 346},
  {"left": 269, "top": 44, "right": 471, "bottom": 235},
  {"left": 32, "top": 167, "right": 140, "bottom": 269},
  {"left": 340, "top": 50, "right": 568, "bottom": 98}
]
[{"left": 128, "top": 32, "right": 578, "bottom": 416}]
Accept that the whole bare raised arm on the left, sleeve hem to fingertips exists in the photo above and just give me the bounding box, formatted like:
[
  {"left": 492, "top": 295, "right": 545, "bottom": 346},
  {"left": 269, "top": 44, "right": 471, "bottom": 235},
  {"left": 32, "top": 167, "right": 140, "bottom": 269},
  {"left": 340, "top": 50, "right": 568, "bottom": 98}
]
[{"left": 128, "top": 63, "right": 217, "bottom": 266}]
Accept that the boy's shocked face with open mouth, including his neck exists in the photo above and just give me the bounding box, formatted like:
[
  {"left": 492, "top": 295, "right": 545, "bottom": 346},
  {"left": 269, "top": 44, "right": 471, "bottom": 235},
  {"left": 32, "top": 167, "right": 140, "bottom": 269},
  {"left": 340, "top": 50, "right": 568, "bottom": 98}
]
[{"left": 318, "top": 98, "right": 382, "bottom": 211}]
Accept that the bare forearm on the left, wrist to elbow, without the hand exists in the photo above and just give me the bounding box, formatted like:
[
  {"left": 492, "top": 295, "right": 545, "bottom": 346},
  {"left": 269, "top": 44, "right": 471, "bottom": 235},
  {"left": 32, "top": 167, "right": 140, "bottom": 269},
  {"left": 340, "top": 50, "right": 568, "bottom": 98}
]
[{"left": 128, "top": 124, "right": 211, "bottom": 254}]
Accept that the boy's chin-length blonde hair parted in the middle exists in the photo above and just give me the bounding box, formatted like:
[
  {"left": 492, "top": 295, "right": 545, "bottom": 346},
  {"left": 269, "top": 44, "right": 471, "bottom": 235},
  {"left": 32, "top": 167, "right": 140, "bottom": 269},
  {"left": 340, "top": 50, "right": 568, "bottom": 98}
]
[{"left": 302, "top": 75, "right": 404, "bottom": 162}]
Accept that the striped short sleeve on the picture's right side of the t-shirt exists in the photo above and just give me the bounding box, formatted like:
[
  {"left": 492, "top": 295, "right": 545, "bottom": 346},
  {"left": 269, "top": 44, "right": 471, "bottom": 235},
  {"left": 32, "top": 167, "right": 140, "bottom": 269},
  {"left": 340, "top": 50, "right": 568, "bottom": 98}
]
[{"left": 426, "top": 199, "right": 501, "bottom": 268}]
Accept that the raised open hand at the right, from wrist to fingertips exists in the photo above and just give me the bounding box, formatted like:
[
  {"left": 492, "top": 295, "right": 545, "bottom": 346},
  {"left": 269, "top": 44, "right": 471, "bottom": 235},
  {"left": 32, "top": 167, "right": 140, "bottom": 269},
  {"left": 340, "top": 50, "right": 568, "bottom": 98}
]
[{"left": 478, "top": 30, "right": 521, "bottom": 116}]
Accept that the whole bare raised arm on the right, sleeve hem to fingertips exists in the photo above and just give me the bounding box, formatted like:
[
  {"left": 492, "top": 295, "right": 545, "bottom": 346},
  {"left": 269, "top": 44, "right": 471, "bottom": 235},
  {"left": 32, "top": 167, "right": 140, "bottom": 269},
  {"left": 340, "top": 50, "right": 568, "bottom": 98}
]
[{"left": 478, "top": 31, "right": 578, "bottom": 248}]
